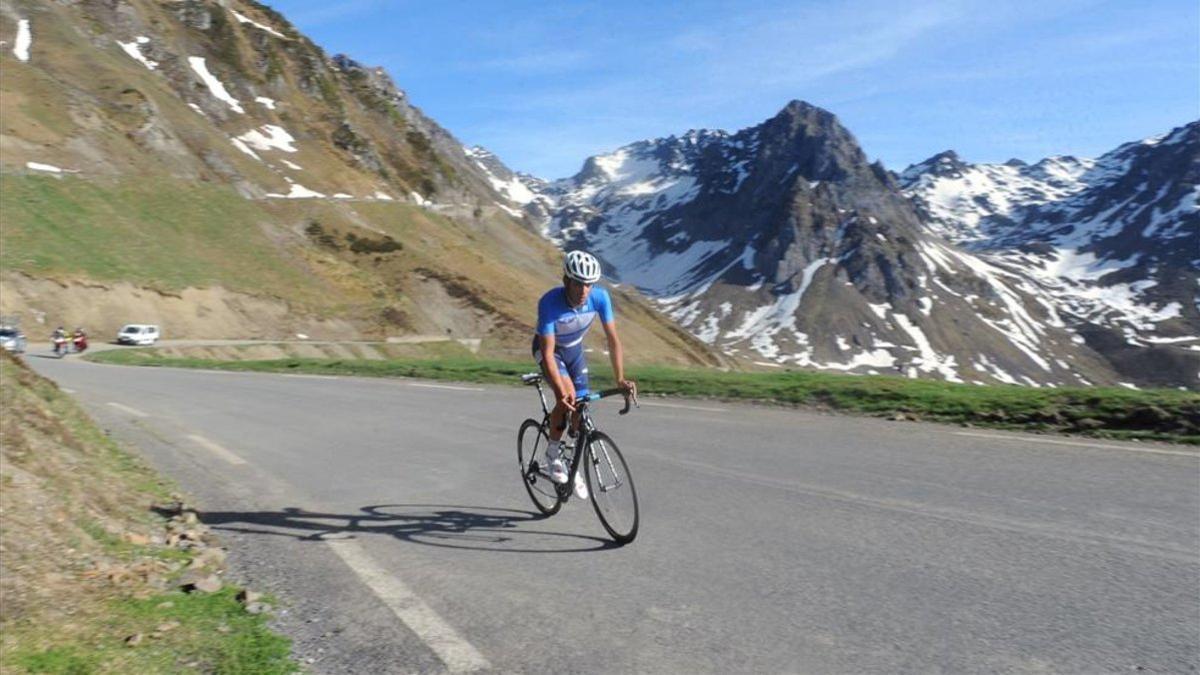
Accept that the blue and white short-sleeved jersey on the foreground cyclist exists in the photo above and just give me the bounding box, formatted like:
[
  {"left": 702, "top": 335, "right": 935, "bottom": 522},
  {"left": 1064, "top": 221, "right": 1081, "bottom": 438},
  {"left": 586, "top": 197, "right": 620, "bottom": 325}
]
[{"left": 532, "top": 286, "right": 613, "bottom": 396}]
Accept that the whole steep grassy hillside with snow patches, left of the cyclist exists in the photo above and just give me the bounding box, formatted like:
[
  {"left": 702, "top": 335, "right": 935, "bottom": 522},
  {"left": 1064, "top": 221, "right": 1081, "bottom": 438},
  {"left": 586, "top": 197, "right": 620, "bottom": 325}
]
[{"left": 0, "top": 0, "right": 718, "bottom": 363}]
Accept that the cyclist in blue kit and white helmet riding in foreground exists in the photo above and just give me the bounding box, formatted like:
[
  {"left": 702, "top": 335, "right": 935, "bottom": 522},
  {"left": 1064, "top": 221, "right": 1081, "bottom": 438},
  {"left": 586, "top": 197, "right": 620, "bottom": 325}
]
[{"left": 533, "top": 251, "right": 636, "bottom": 498}]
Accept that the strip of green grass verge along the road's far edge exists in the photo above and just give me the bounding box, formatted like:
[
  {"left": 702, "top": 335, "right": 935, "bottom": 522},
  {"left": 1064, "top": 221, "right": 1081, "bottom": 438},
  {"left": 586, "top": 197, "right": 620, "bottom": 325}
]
[{"left": 90, "top": 350, "right": 1200, "bottom": 444}]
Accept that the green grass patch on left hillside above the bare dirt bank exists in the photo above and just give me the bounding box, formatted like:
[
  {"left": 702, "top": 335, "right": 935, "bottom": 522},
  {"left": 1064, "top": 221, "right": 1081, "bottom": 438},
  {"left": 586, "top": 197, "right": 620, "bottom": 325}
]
[{"left": 0, "top": 175, "right": 319, "bottom": 297}]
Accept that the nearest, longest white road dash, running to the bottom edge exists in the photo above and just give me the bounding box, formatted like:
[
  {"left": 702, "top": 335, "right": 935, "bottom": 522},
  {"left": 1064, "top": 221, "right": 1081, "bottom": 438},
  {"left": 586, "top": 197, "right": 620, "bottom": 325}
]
[{"left": 329, "top": 539, "right": 492, "bottom": 673}]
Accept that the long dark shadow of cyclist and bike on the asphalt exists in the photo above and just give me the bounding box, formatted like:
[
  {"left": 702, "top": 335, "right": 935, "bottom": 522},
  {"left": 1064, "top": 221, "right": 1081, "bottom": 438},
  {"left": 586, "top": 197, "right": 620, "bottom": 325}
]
[{"left": 184, "top": 504, "right": 619, "bottom": 554}]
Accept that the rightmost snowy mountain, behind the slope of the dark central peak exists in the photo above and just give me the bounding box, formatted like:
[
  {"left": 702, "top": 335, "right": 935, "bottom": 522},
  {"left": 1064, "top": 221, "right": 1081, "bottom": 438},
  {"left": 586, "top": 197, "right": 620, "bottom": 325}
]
[{"left": 901, "top": 121, "right": 1200, "bottom": 384}]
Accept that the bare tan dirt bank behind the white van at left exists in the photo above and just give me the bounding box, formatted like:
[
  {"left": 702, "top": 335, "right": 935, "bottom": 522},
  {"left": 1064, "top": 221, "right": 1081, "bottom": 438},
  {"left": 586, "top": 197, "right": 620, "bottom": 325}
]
[{"left": 0, "top": 274, "right": 362, "bottom": 340}]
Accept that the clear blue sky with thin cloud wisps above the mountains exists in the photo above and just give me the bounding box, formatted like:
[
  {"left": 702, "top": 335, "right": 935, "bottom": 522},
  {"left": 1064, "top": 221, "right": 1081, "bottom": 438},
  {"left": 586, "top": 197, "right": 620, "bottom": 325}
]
[{"left": 268, "top": 0, "right": 1200, "bottom": 178}]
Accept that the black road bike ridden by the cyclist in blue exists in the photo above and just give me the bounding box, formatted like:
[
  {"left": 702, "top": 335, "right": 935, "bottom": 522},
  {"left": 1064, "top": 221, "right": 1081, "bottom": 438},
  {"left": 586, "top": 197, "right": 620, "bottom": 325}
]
[{"left": 517, "top": 372, "right": 637, "bottom": 544}]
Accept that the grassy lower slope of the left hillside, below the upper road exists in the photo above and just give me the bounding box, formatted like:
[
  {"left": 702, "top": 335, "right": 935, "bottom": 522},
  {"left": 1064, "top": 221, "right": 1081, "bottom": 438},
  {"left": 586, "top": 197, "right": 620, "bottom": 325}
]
[{"left": 0, "top": 175, "right": 715, "bottom": 364}]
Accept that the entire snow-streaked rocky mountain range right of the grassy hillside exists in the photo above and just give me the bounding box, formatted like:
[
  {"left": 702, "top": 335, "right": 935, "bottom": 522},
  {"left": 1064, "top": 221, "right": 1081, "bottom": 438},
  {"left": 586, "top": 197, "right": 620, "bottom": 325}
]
[{"left": 480, "top": 101, "right": 1200, "bottom": 386}]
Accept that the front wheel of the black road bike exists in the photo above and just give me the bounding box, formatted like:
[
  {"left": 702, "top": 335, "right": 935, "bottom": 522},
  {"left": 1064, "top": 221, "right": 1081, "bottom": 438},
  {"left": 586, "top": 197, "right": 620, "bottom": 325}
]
[{"left": 583, "top": 431, "right": 638, "bottom": 544}]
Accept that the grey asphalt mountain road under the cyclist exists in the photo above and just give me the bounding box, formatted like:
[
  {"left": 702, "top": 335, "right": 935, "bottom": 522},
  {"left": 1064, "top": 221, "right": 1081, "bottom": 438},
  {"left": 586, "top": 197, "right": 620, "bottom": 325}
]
[{"left": 28, "top": 354, "right": 1200, "bottom": 673}]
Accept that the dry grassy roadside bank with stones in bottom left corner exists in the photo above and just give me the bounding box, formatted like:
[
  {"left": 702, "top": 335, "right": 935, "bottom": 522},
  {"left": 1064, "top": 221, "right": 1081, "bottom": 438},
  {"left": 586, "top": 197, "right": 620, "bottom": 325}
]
[{"left": 0, "top": 352, "right": 296, "bottom": 674}]
